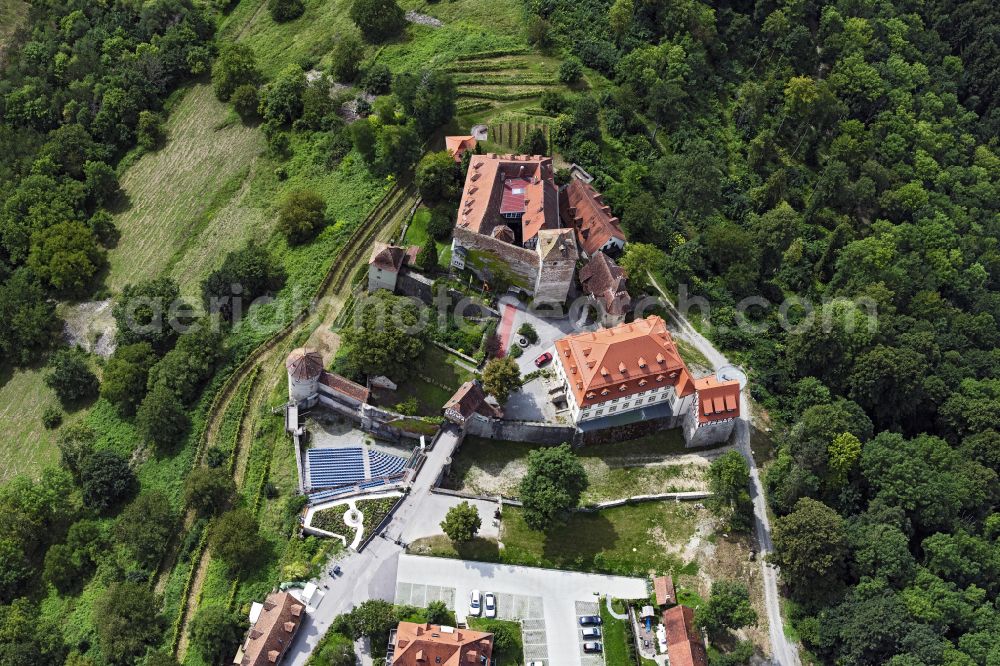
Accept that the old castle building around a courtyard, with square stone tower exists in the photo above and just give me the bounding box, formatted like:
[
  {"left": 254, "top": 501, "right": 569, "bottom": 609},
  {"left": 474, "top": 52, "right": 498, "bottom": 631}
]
[{"left": 452, "top": 153, "right": 579, "bottom": 302}]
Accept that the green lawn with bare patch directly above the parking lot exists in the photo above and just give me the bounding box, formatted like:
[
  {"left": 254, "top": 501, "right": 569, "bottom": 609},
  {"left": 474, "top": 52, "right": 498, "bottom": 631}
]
[{"left": 500, "top": 502, "right": 696, "bottom": 576}]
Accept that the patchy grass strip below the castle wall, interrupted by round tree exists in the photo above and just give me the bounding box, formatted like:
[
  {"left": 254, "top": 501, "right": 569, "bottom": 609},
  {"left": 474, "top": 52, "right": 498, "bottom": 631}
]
[{"left": 449, "top": 430, "right": 705, "bottom": 504}]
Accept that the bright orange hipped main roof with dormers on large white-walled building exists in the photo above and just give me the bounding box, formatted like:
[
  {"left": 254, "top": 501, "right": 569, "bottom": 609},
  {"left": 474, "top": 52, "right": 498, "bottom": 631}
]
[{"left": 556, "top": 316, "right": 694, "bottom": 407}]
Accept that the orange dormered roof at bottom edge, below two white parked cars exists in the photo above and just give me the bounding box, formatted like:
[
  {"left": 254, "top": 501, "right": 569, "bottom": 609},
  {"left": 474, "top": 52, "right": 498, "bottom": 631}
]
[{"left": 392, "top": 622, "right": 493, "bottom": 666}]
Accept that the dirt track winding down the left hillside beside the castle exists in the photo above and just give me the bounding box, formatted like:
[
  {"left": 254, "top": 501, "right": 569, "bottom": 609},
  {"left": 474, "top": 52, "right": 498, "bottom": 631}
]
[{"left": 174, "top": 188, "right": 419, "bottom": 661}]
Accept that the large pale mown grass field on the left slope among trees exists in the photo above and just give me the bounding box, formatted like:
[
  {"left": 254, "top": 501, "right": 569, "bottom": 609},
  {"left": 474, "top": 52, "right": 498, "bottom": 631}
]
[{"left": 107, "top": 84, "right": 271, "bottom": 292}]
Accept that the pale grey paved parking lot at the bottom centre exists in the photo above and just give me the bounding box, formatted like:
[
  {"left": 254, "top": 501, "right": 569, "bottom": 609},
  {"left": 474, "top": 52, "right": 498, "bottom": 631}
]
[{"left": 396, "top": 555, "right": 648, "bottom": 666}]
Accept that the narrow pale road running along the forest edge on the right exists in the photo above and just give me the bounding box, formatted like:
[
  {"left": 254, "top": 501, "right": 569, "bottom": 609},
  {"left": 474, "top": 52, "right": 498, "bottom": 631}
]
[{"left": 650, "top": 276, "right": 800, "bottom": 666}]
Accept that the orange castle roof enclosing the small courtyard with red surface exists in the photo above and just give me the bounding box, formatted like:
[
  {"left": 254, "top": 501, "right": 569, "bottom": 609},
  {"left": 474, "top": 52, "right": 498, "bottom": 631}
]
[{"left": 456, "top": 154, "right": 559, "bottom": 243}]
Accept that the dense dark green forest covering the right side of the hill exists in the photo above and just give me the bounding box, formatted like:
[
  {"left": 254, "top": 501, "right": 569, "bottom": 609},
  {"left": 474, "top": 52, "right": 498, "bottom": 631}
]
[{"left": 530, "top": 0, "right": 1000, "bottom": 666}]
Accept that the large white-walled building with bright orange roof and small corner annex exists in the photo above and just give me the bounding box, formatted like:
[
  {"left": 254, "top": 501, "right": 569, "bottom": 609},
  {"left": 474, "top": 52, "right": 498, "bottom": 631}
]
[{"left": 554, "top": 316, "right": 740, "bottom": 446}]
